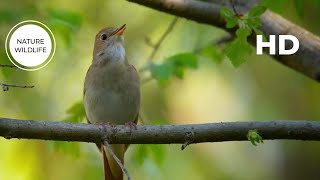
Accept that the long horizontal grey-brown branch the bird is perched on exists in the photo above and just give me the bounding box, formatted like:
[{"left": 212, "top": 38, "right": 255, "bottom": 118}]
[{"left": 0, "top": 118, "right": 320, "bottom": 144}]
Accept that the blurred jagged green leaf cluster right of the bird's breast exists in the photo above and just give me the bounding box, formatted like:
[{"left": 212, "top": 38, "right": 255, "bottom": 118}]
[{"left": 149, "top": 53, "right": 198, "bottom": 85}]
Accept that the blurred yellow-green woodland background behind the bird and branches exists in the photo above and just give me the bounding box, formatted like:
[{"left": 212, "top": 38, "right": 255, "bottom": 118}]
[{"left": 0, "top": 0, "right": 320, "bottom": 180}]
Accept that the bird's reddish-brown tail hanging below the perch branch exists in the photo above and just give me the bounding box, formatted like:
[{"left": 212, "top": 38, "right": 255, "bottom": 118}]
[{"left": 97, "top": 144, "right": 127, "bottom": 180}]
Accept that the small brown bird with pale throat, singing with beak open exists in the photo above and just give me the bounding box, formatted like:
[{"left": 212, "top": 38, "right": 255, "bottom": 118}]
[{"left": 84, "top": 25, "right": 140, "bottom": 180}]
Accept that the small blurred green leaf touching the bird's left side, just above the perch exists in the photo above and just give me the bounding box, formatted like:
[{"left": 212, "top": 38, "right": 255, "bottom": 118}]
[{"left": 63, "top": 101, "right": 86, "bottom": 122}]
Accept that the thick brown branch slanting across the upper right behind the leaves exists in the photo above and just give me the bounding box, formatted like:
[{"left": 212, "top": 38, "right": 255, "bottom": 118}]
[{"left": 127, "top": 0, "right": 320, "bottom": 82}]
